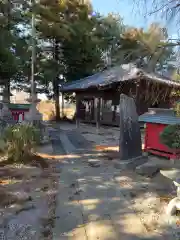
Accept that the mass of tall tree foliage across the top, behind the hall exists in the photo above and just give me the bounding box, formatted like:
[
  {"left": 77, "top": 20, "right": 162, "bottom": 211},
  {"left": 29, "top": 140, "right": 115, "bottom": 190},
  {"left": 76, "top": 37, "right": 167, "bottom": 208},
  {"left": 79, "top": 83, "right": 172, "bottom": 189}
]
[{"left": 0, "top": 0, "right": 177, "bottom": 104}]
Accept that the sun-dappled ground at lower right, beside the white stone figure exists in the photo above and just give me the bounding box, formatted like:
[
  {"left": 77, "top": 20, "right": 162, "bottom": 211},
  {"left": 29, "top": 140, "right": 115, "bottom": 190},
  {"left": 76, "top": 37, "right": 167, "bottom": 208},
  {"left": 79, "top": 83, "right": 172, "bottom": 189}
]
[{"left": 115, "top": 171, "right": 180, "bottom": 240}]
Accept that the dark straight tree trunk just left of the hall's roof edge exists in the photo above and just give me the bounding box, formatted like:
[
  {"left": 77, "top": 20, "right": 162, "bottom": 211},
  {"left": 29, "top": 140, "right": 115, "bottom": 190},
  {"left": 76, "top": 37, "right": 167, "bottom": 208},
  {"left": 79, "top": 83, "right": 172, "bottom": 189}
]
[{"left": 53, "top": 40, "right": 60, "bottom": 121}]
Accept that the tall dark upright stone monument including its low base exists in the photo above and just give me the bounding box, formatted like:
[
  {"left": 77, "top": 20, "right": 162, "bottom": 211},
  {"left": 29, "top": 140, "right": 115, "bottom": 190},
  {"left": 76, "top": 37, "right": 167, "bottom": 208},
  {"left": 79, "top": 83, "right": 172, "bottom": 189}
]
[{"left": 116, "top": 94, "right": 148, "bottom": 169}]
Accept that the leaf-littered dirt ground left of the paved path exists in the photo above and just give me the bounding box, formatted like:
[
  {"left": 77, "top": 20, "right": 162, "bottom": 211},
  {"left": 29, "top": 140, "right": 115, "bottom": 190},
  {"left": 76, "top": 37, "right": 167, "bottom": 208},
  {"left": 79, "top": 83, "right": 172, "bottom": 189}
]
[{"left": 0, "top": 143, "right": 59, "bottom": 240}]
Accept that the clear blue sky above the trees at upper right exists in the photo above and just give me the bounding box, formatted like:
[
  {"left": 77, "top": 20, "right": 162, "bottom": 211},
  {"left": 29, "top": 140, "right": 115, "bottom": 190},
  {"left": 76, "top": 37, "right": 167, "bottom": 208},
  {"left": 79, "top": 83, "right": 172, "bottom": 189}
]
[{"left": 91, "top": 0, "right": 177, "bottom": 38}]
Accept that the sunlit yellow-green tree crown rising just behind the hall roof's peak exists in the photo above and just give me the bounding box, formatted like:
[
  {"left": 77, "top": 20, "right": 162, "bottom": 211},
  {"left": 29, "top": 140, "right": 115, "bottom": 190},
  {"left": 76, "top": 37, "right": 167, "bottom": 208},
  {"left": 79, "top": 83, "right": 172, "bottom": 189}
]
[{"left": 121, "top": 23, "right": 174, "bottom": 71}]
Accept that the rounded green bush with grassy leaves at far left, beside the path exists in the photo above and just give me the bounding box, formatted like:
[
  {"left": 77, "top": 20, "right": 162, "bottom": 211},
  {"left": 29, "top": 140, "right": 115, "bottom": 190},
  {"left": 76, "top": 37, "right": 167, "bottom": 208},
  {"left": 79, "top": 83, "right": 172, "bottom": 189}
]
[{"left": 4, "top": 124, "right": 40, "bottom": 162}]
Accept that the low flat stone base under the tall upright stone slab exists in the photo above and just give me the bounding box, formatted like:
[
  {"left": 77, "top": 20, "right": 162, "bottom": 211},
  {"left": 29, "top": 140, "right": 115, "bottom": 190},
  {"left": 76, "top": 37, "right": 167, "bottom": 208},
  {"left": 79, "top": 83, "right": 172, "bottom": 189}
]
[{"left": 114, "top": 156, "right": 148, "bottom": 170}]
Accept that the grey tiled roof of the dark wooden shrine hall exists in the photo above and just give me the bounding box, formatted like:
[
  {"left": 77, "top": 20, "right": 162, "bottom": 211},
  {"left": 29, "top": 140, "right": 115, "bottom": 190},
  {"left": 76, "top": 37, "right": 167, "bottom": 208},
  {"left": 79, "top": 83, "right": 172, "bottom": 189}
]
[{"left": 61, "top": 64, "right": 180, "bottom": 92}]
